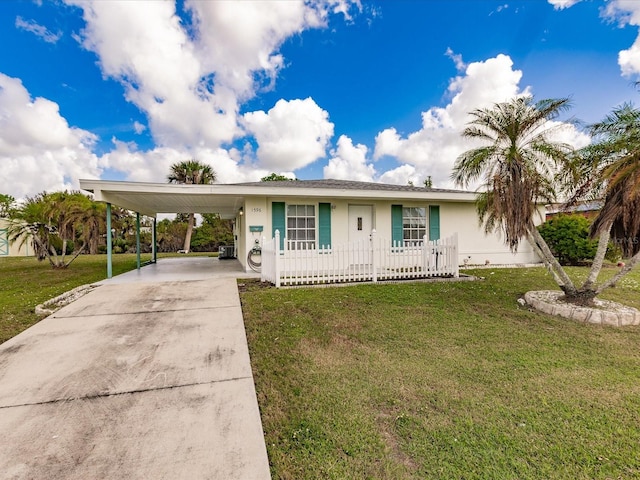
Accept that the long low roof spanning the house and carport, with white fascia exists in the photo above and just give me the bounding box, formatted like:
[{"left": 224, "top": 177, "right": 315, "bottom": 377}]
[{"left": 80, "top": 179, "right": 476, "bottom": 218}]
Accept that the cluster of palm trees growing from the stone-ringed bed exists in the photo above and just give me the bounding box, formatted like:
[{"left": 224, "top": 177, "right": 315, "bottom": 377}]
[{"left": 453, "top": 97, "right": 640, "bottom": 304}]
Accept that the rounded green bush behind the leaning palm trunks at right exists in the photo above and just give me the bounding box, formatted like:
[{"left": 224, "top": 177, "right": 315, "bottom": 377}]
[{"left": 538, "top": 214, "right": 598, "bottom": 265}]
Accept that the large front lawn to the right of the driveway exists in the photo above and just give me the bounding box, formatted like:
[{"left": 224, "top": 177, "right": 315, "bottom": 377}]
[{"left": 242, "top": 268, "right": 640, "bottom": 479}]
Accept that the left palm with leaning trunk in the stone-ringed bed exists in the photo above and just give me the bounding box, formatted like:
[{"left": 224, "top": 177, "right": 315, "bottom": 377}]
[{"left": 452, "top": 96, "right": 578, "bottom": 297}]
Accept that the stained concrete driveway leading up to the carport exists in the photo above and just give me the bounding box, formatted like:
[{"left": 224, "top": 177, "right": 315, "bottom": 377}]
[{"left": 0, "top": 259, "right": 270, "bottom": 480}]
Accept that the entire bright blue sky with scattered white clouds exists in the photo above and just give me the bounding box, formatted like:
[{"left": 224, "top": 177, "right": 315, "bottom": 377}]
[{"left": 0, "top": 0, "right": 640, "bottom": 198}]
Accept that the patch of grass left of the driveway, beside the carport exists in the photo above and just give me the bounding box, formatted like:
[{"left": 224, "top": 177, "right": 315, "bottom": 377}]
[{"left": 0, "top": 254, "right": 151, "bottom": 343}]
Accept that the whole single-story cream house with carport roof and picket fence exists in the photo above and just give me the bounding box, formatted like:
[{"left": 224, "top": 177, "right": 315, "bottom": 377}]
[{"left": 80, "top": 180, "right": 544, "bottom": 285}]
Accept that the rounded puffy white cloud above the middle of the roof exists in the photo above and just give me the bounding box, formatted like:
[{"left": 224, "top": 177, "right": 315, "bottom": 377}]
[{"left": 242, "top": 98, "right": 333, "bottom": 171}]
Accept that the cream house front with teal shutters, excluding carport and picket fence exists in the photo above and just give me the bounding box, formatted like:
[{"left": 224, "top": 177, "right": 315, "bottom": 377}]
[{"left": 230, "top": 180, "right": 544, "bottom": 267}]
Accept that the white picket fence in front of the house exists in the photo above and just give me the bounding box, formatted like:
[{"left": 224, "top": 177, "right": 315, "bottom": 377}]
[{"left": 261, "top": 230, "right": 458, "bottom": 287}]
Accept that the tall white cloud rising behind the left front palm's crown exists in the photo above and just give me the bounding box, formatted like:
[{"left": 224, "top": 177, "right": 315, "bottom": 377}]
[{"left": 374, "top": 55, "right": 588, "bottom": 188}]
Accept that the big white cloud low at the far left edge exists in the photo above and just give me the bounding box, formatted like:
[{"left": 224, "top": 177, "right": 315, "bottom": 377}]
[{"left": 0, "top": 73, "right": 101, "bottom": 198}]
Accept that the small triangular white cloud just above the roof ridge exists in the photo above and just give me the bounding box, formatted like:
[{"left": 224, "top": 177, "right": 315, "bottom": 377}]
[{"left": 323, "top": 135, "right": 376, "bottom": 182}]
